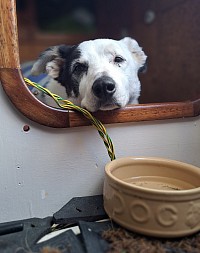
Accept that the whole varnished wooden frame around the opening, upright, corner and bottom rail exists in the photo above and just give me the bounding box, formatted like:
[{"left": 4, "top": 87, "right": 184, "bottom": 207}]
[{"left": 0, "top": 0, "right": 200, "bottom": 128}]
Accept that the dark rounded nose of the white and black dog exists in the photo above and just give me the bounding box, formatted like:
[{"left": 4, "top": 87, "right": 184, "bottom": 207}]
[{"left": 92, "top": 76, "right": 116, "bottom": 99}]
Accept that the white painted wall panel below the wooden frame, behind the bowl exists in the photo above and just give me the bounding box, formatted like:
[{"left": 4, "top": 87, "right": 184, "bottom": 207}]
[{"left": 0, "top": 86, "right": 200, "bottom": 222}]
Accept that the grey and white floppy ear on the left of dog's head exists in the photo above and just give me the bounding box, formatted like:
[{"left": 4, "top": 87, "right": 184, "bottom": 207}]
[{"left": 31, "top": 45, "right": 68, "bottom": 78}]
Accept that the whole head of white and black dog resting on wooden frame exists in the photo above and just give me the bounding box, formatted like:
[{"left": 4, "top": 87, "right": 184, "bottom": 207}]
[{"left": 32, "top": 37, "right": 146, "bottom": 111}]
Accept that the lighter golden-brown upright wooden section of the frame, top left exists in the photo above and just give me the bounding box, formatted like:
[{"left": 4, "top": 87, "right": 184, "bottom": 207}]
[{"left": 0, "top": 0, "right": 20, "bottom": 68}]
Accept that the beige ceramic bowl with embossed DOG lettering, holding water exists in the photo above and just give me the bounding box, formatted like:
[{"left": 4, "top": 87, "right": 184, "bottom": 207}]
[{"left": 103, "top": 157, "right": 200, "bottom": 237}]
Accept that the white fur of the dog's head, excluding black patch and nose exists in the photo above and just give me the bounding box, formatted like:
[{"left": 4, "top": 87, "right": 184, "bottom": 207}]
[{"left": 32, "top": 37, "right": 147, "bottom": 112}]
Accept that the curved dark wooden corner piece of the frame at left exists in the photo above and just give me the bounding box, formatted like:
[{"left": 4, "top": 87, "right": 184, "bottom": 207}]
[{"left": 0, "top": 69, "right": 69, "bottom": 127}]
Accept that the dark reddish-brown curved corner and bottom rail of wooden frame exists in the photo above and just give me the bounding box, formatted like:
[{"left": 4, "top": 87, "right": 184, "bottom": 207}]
[{"left": 0, "top": 68, "right": 200, "bottom": 128}]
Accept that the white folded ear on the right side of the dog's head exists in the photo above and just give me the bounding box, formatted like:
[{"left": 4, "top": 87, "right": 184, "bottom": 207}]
[{"left": 121, "top": 37, "right": 147, "bottom": 70}]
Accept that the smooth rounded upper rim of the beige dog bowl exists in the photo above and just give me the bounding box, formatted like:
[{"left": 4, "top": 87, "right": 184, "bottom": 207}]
[{"left": 105, "top": 156, "right": 200, "bottom": 197}]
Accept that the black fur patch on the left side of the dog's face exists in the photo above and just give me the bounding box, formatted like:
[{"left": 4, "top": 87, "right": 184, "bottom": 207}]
[{"left": 55, "top": 45, "right": 81, "bottom": 97}]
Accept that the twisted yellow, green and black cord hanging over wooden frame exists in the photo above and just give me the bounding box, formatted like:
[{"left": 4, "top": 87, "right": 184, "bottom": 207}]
[{"left": 24, "top": 78, "right": 115, "bottom": 161}]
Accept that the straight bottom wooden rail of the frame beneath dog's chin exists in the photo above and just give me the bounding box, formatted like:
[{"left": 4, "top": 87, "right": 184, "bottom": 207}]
[{"left": 69, "top": 102, "right": 194, "bottom": 127}]
